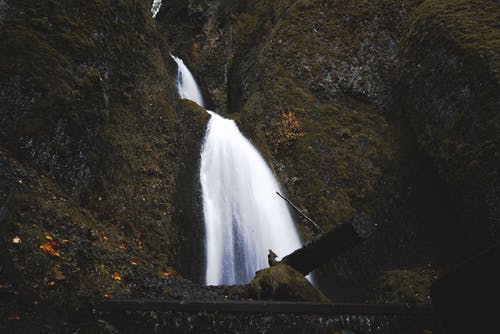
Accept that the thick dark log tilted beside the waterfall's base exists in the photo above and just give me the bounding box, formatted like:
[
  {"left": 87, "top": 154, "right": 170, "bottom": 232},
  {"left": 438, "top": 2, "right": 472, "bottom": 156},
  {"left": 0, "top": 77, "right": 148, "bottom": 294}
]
[{"left": 281, "top": 216, "right": 375, "bottom": 276}]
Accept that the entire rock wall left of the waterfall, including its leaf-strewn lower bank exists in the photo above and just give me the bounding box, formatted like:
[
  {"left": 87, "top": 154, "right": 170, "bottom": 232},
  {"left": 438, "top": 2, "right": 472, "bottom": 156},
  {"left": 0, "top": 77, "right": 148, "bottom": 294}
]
[{"left": 0, "top": 0, "right": 208, "bottom": 331}]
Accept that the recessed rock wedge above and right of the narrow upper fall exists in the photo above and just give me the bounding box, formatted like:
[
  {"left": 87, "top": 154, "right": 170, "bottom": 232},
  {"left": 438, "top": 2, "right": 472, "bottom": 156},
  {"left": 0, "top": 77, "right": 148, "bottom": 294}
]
[{"left": 157, "top": 0, "right": 238, "bottom": 112}]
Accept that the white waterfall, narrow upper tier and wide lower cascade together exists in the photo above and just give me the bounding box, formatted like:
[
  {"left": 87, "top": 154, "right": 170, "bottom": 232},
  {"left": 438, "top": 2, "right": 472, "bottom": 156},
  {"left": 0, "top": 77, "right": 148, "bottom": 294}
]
[{"left": 172, "top": 56, "right": 301, "bottom": 285}]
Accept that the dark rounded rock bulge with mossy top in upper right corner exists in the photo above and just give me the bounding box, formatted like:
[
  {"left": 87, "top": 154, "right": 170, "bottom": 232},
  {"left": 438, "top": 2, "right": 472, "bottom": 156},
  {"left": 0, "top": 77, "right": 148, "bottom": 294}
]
[{"left": 399, "top": 0, "right": 500, "bottom": 249}]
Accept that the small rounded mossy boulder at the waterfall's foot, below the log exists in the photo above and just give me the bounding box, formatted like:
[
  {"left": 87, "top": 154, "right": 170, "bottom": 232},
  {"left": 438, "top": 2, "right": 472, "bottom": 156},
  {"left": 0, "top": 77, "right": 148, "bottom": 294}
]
[{"left": 249, "top": 263, "right": 330, "bottom": 302}]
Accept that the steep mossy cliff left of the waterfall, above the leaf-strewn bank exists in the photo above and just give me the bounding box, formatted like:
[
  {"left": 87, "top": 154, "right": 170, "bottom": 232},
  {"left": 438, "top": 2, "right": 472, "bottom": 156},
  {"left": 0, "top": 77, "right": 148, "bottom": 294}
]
[{"left": 0, "top": 0, "right": 203, "bottom": 268}]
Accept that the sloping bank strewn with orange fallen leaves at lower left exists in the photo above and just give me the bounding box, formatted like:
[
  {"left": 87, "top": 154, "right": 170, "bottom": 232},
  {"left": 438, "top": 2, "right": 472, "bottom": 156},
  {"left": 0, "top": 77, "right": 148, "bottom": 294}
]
[{"left": 0, "top": 148, "right": 182, "bottom": 332}]
